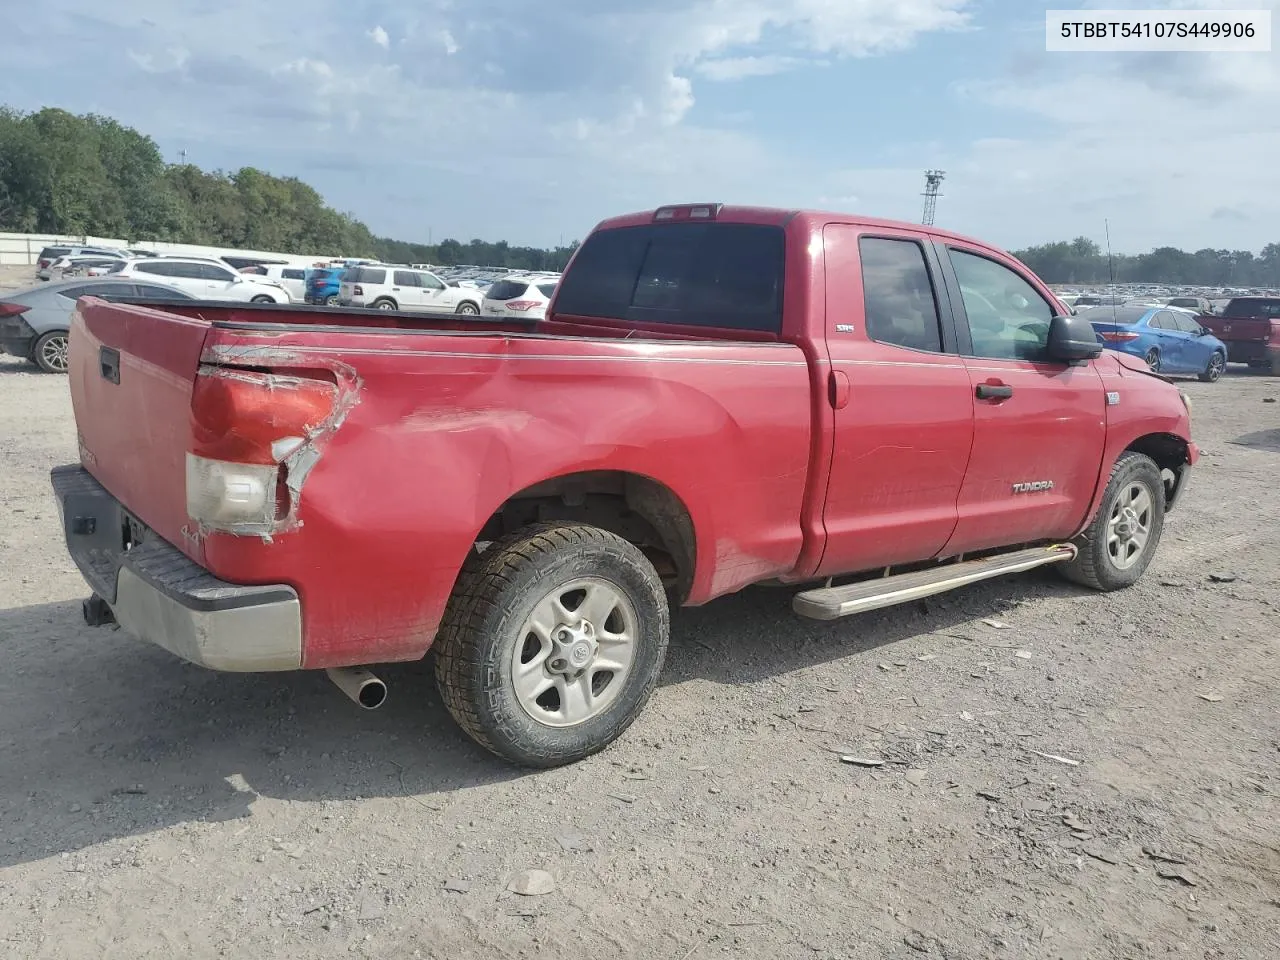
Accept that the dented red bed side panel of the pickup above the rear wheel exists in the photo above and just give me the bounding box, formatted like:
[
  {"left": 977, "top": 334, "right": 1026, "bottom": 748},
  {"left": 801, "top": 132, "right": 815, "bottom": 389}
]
[{"left": 202, "top": 324, "right": 812, "bottom": 668}]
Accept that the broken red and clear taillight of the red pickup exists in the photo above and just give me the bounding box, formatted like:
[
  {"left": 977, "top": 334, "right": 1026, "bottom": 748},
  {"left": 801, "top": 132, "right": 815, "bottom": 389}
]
[{"left": 187, "top": 366, "right": 338, "bottom": 534}]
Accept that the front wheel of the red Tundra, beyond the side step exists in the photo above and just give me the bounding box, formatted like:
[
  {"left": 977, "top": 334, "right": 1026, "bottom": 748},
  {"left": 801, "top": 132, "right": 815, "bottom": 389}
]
[{"left": 1057, "top": 451, "right": 1165, "bottom": 590}]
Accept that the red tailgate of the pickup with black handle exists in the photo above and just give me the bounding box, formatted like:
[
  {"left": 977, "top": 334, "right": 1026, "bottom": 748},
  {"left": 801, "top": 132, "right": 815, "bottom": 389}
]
[{"left": 69, "top": 297, "right": 210, "bottom": 562}]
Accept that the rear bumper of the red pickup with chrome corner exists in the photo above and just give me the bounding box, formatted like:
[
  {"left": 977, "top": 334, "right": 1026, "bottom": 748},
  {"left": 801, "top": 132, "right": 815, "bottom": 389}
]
[{"left": 50, "top": 463, "right": 302, "bottom": 673}]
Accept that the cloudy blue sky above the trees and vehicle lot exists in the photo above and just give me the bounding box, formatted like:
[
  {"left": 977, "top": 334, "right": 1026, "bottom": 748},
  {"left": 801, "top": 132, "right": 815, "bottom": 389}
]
[{"left": 0, "top": 0, "right": 1280, "bottom": 252}]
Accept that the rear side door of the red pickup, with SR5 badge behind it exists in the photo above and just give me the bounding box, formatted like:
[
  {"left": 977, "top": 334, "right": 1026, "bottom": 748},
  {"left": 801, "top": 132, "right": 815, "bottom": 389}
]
[{"left": 818, "top": 224, "right": 974, "bottom": 576}]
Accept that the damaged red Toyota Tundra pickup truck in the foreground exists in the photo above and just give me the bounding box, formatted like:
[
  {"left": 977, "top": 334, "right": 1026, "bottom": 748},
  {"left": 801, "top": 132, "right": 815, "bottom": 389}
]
[{"left": 52, "top": 205, "right": 1198, "bottom": 767}]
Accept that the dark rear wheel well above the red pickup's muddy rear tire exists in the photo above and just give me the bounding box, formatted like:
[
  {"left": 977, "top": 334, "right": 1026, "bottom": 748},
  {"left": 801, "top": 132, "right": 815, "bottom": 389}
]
[{"left": 476, "top": 470, "right": 696, "bottom": 600}]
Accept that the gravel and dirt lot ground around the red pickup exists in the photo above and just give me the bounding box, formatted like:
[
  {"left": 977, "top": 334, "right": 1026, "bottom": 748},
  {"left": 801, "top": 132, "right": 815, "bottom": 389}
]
[{"left": 0, "top": 335, "right": 1280, "bottom": 960}]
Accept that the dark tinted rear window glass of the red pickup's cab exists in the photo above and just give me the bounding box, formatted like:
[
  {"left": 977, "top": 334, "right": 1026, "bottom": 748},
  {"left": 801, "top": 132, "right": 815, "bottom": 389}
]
[{"left": 557, "top": 223, "right": 783, "bottom": 333}]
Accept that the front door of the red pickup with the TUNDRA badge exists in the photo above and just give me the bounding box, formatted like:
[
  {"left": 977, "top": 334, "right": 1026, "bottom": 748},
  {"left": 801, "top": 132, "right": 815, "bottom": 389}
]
[{"left": 936, "top": 241, "right": 1106, "bottom": 554}]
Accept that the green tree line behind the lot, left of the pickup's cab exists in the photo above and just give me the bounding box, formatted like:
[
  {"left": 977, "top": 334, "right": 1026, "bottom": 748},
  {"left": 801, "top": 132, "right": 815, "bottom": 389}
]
[{"left": 0, "top": 106, "right": 573, "bottom": 270}]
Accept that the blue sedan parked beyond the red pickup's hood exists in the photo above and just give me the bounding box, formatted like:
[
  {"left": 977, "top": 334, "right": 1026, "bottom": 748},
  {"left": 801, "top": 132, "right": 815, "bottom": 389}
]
[{"left": 1080, "top": 306, "right": 1226, "bottom": 383}]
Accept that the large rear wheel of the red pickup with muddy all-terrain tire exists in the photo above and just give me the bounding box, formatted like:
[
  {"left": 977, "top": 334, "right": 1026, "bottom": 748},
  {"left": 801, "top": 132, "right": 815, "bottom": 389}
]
[{"left": 433, "top": 524, "right": 671, "bottom": 767}]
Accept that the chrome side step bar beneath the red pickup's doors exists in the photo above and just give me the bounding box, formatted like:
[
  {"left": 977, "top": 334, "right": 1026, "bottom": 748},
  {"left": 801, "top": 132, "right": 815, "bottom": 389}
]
[{"left": 791, "top": 543, "right": 1076, "bottom": 620}]
